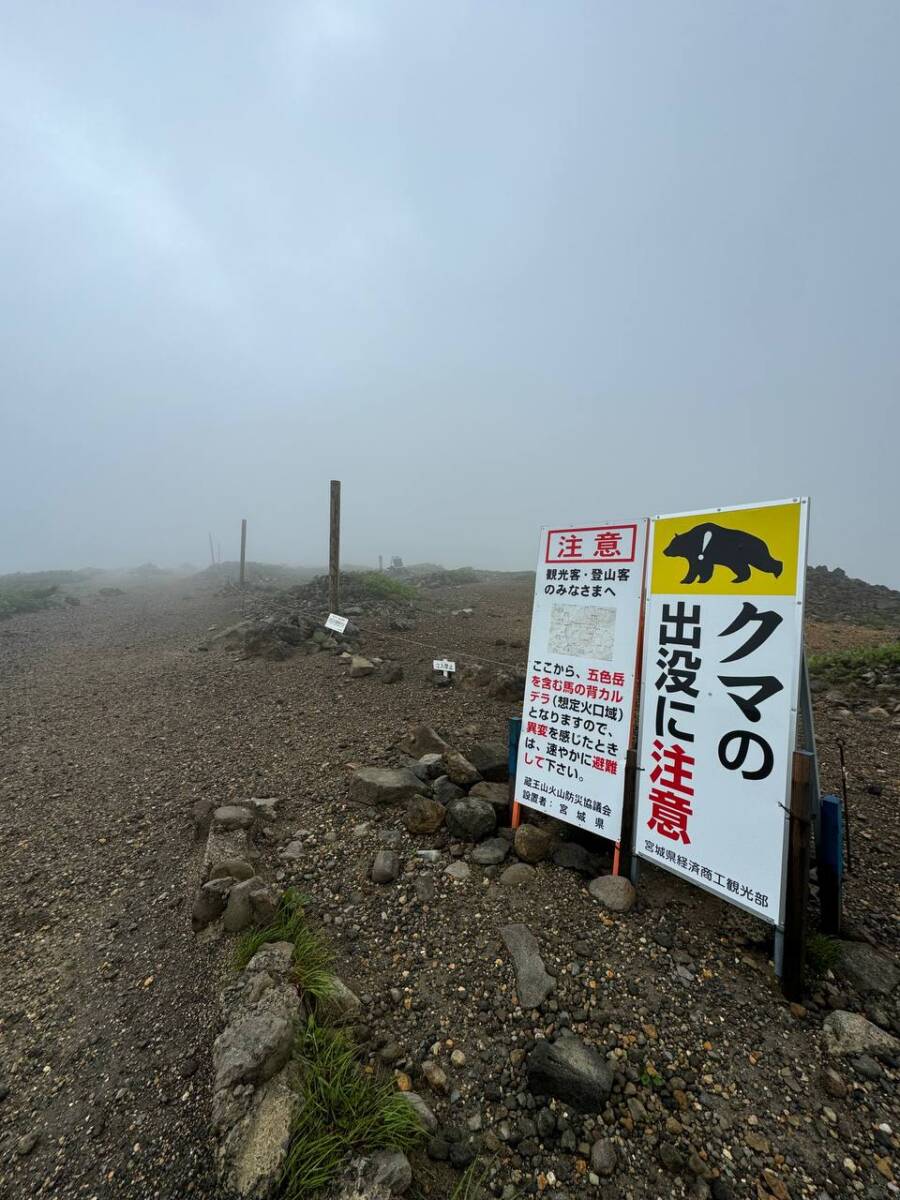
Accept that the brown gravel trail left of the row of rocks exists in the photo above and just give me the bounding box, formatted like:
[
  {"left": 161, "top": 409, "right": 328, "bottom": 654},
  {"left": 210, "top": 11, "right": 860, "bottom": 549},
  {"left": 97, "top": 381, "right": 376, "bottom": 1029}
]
[{"left": 0, "top": 586, "right": 243, "bottom": 1200}]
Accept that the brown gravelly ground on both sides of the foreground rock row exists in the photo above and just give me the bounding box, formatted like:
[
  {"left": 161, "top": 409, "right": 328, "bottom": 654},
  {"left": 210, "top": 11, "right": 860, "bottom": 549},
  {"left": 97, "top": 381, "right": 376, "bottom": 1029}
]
[{"left": 0, "top": 583, "right": 900, "bottom": 1200}]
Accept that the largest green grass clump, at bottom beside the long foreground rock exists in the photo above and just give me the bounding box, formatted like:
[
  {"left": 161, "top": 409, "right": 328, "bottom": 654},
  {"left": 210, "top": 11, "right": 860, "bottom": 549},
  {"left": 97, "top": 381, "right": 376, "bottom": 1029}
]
[{"left": 278, "top": 1016, "right": 425, "bottom": 1200}]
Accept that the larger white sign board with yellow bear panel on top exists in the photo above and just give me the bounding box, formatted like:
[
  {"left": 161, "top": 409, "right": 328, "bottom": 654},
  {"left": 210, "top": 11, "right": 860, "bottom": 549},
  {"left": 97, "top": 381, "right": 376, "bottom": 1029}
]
[{"left": 635, "top": 499, "right": 809, "bottom": 925}]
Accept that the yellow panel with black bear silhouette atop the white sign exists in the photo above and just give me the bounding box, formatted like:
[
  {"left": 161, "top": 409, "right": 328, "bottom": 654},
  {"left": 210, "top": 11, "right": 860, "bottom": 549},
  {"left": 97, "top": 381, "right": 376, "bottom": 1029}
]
[{"left": 650, "top": 500, "right": 803, "bottom": 595}]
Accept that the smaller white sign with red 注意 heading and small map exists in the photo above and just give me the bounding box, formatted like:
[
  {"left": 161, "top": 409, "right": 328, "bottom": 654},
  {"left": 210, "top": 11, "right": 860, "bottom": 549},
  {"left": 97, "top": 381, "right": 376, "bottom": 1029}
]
[{"left": 516, "top": 521, "right": 647, "bottom": 841}]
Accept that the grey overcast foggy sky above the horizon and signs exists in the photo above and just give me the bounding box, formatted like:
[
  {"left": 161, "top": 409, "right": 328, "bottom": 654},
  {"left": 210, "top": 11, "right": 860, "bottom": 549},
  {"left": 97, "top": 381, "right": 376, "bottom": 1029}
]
[{"left": 0, "top": 0, "right": 900, "bottom": 586}]
